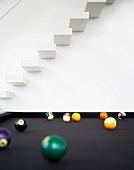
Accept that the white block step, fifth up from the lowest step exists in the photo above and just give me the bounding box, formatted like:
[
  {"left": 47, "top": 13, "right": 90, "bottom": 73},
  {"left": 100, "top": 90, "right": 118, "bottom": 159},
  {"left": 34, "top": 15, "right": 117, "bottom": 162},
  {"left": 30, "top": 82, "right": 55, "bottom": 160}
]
[{"left": 54, "top": 28, "right": 72, "bottom": 45}]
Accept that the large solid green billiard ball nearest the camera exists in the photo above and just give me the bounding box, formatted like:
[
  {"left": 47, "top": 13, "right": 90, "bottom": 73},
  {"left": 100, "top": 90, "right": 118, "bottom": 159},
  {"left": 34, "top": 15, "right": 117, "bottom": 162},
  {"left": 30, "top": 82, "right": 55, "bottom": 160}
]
[{"left": 41, "top": 135, "right": 67, "bottom": 162}]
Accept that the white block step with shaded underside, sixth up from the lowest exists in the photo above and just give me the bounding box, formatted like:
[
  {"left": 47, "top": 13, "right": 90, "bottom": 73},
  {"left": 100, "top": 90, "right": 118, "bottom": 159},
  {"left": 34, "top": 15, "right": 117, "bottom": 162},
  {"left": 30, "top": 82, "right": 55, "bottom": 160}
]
[{"left": 69, "top": 12, "right": 89, "bottom": 31}]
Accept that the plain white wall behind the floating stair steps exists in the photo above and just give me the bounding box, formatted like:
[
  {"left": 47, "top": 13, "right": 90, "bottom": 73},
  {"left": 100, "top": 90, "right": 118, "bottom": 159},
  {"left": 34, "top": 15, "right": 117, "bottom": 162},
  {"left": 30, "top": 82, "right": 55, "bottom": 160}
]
[{"left": 0, "top": 0, "right": 134, "bottom": 111}]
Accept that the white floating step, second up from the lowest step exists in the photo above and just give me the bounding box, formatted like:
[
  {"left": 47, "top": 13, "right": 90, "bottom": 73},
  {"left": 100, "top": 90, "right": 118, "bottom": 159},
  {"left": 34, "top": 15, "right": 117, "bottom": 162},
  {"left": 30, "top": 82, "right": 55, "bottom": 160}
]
[{"left": 5, "top": 75, "right": 27, "bottom": 86}]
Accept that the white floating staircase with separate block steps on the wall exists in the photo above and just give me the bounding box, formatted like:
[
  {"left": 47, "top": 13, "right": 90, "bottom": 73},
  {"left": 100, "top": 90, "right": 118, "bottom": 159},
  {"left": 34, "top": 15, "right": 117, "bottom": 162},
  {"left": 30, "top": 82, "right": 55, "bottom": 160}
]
[{"left": 0, "top": 0, "right": 114, "bottom": 99}]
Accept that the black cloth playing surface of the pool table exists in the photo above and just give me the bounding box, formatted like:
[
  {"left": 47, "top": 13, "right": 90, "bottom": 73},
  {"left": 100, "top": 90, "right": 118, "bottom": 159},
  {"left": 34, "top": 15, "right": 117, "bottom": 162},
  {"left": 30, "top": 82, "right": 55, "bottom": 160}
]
[{"left": 0, "top": 114, "right": 134, "bottom": 170}]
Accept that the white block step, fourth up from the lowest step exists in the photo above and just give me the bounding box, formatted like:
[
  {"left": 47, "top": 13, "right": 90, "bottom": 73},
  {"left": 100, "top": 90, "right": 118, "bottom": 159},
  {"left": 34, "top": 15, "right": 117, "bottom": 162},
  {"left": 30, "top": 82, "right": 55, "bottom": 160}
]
[{"left": 38, "top": 44, "right": 56, "bottom": 58}]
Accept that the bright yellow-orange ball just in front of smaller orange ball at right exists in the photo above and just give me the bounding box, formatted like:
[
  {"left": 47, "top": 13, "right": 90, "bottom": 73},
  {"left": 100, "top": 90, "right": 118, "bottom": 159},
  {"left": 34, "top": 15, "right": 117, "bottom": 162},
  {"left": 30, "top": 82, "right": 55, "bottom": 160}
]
[{"left": 104, "top": 117, "right": 117, "bottom": 130}]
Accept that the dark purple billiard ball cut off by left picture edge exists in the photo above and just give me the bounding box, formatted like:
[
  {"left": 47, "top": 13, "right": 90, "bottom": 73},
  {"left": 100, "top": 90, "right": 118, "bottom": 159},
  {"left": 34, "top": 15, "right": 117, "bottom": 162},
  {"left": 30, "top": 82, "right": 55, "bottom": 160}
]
[{"left": 0, "top": 128, "right": 11, "bottom": 149}]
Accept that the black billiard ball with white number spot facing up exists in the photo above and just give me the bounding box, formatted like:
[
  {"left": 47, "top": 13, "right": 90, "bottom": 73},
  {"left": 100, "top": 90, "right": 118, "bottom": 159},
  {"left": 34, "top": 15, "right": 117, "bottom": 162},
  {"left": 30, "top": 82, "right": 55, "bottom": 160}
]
[{"left": 15, "top": 119, "right": 27, "bottom": 132}]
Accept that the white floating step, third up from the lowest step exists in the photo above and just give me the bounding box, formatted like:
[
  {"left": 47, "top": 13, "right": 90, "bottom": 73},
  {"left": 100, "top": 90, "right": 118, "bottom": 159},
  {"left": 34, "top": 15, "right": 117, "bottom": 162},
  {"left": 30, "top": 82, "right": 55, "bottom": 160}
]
[{"left": 21, "top": 60, "right": 41, "bottom": 72}]
